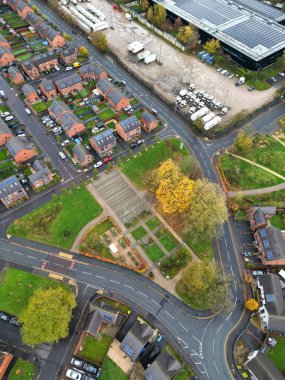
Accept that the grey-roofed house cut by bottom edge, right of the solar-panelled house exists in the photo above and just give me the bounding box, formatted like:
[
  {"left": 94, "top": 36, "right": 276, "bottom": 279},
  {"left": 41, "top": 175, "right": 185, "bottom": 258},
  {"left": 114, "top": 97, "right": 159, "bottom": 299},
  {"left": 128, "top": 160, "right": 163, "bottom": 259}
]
[{"left": 144, "top": 352, "right": 181, "bottom": 380}]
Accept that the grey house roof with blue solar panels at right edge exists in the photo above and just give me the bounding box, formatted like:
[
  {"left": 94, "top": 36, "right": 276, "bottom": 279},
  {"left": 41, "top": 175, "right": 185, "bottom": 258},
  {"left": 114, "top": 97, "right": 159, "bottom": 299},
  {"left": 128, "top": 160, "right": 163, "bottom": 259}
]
[{"left": 257, "top": 226, "right": 285, "bottom": 261}]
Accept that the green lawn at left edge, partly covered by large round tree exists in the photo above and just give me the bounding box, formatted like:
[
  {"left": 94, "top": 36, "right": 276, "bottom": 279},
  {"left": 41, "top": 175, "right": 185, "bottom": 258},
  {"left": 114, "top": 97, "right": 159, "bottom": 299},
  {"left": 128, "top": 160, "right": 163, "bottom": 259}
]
[{"left": 0, "top": 268, "right": 58, "bottom": 316}]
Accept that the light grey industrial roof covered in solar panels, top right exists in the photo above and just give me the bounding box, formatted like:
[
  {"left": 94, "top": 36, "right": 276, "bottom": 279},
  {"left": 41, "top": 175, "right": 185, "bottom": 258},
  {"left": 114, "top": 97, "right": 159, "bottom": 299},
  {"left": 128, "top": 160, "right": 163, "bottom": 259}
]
[{"left": 154, "top": 0, "right": 285, "bottom": 61}]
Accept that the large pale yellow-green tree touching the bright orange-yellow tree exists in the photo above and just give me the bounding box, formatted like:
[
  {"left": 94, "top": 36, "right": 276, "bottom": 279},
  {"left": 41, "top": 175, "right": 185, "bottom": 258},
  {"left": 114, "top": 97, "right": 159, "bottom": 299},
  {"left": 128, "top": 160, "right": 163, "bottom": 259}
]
[{"left": 182, "top": 179, "right": 228, "bottom": 242}]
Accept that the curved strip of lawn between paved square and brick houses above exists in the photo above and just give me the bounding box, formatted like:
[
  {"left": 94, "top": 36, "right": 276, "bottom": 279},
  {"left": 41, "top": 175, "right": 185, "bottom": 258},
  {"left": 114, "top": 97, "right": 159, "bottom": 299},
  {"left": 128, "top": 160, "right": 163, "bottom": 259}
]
[{"left": 122, "top": 138, "right": 189, "bottom": 189}]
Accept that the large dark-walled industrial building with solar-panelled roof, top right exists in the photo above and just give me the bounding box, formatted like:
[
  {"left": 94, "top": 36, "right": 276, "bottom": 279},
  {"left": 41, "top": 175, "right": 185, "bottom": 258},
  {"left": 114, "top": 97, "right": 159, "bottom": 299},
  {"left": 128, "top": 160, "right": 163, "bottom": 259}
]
[{"left": 153, "top": 0, "right": 285, "bottom": 70}]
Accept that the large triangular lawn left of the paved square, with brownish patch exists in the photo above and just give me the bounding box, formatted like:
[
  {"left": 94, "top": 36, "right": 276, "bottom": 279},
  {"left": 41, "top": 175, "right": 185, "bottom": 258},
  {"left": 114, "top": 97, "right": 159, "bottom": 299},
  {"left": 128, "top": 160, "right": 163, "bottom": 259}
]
[{"left": 8, "top": 186, "right": 102, "bottom": 249}]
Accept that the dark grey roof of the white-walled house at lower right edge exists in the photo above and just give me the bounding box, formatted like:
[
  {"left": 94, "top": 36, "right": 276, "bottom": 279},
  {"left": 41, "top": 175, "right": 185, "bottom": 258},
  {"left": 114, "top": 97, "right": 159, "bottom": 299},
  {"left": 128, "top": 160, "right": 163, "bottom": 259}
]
[{"left": 259, "top": 273, "right": 285, "bottom": 332}]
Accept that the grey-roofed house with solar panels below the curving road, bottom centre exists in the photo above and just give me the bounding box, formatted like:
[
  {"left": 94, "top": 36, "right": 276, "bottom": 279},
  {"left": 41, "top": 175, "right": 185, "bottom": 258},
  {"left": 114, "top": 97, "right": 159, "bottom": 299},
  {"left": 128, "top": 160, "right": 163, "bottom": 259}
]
[{"left": 120, "top": 321, "right": 153, "bottom": 362}]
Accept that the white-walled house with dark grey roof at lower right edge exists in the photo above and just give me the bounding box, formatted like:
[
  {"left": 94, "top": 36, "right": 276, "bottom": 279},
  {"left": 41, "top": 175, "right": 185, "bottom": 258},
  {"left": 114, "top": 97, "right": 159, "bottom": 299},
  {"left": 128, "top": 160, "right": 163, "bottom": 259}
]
[{"left": 256, "top": 273, "right": 285, "bottom": 334}]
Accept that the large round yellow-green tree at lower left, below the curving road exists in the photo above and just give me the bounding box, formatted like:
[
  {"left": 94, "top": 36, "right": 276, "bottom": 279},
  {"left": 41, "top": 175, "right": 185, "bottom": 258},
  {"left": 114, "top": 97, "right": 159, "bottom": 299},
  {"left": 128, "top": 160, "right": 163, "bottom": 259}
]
[{"left": 19, "top": 286, "right": 76, "bottom": 347}]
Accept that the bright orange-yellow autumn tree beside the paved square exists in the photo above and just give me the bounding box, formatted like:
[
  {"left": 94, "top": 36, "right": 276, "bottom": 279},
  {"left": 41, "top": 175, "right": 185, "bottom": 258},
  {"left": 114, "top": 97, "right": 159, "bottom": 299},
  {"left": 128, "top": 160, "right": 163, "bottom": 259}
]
[{"left": 155, "top": 159, "right": 194, "bottom": 214}]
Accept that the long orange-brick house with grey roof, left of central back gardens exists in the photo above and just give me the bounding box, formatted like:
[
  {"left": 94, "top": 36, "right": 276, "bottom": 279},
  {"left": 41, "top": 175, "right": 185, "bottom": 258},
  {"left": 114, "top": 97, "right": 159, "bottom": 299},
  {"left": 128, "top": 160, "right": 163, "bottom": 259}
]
[{"left": 49, "top": 101, "right": 86, "bottom": 137}]
